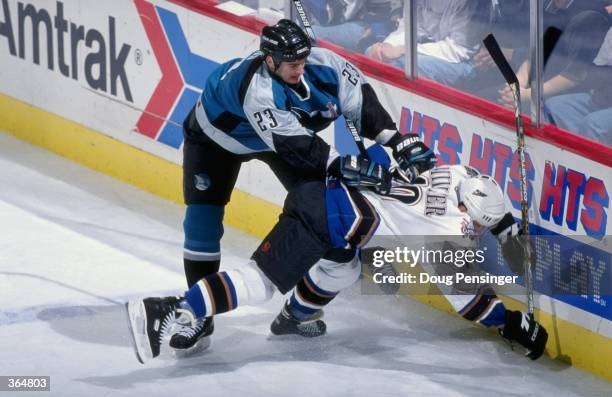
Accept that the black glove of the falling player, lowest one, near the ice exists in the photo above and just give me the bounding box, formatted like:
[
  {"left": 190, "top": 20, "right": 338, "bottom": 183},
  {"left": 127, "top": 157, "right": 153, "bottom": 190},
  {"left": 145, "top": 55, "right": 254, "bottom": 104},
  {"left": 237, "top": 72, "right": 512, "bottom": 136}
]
[{"left": 499, "top": 310, "right": 548, "bottom": 360}]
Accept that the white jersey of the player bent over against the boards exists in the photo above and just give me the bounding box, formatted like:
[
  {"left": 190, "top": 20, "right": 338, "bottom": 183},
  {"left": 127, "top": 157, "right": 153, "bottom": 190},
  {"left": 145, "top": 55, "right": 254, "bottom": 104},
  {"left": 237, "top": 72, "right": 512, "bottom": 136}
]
[{"left": 326, "top": 165, "right": 505, "bottom": 327}]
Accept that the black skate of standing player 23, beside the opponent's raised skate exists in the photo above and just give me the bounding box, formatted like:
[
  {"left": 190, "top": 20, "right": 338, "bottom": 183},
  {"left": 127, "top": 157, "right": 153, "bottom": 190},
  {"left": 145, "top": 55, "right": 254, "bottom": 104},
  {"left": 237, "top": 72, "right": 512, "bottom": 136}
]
[{"left": 170, "top": 315, "right": 215, "bottom": 357}]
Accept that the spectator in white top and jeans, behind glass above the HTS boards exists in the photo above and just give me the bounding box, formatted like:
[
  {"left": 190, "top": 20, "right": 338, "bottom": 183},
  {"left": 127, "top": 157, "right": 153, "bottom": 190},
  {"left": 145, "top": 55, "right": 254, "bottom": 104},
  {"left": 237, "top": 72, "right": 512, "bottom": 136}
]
[{"left": 366, "top": 0, "right": 491, "bottom": 87}]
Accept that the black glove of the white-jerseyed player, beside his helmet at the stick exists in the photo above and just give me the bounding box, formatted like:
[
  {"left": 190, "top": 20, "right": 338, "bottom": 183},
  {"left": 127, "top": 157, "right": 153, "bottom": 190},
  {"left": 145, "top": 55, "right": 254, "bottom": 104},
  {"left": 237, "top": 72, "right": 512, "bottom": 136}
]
[{"left": 491, "top": 212, "right": 537, "bottom": 274}]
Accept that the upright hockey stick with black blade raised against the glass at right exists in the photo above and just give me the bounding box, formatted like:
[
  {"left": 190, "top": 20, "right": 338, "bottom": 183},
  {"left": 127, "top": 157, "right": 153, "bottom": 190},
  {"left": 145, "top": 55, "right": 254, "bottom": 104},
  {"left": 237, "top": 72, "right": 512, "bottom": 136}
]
[{"left": 482, "top": 33, "right": 533, "bottom": 317}]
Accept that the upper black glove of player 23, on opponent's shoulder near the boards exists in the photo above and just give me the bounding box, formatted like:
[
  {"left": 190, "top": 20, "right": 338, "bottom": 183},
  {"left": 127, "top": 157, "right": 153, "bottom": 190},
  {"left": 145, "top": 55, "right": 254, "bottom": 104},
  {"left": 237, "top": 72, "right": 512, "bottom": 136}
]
[{"left": 387, "top": 132, "right": 437, "bottom": 182}]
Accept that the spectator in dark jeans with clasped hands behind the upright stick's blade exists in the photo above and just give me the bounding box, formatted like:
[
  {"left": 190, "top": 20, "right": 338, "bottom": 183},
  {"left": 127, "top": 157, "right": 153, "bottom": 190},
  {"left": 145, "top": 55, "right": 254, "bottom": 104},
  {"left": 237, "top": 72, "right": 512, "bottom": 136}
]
[{"left": 498, "top": 0, "right": 610, "bottom": 110}]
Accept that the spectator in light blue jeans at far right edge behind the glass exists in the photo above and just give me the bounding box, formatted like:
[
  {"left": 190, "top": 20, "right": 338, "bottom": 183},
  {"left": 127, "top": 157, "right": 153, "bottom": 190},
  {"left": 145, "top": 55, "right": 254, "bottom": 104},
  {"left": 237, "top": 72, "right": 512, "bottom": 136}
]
[{"left": 545, "top": 27, "right": 612, "bottom": 146}]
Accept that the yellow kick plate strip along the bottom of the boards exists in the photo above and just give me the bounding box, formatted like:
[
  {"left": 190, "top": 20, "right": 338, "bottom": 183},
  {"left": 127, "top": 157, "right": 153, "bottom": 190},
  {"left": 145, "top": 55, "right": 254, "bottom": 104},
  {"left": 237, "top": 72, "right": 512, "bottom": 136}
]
[{"left": 0, "top": 94, "right": 612, "bottom": 380}]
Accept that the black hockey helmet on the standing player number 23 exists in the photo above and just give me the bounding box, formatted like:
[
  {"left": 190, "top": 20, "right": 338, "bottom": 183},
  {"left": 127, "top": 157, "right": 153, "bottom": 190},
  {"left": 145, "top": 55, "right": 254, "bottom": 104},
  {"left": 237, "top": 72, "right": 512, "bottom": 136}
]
[{"left": 259, "top": 19, "right": 311, "bottom": 67}]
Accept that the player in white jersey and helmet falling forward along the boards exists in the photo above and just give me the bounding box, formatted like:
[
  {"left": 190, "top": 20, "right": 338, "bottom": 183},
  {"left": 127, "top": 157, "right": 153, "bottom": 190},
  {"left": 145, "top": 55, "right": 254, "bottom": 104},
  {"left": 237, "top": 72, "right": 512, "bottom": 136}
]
[{"left": 127, "top": 148, "right": 547, "bottom": 362}]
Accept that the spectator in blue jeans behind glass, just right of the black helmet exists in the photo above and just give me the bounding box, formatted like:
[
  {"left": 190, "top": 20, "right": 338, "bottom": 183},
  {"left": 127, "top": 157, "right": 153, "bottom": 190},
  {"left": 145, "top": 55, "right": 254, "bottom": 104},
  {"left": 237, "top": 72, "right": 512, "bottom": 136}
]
[{"left": 302, "top": 0, "right": 401, "bottom": 53}]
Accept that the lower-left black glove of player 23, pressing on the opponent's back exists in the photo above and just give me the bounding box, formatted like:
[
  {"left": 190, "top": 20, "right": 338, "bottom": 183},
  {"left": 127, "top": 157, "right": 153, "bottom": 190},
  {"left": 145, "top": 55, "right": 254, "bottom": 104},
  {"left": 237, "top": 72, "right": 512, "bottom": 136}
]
[{"left": 327, "top": 156, "right": 391, "bottom": 195}]
